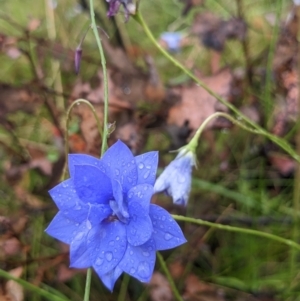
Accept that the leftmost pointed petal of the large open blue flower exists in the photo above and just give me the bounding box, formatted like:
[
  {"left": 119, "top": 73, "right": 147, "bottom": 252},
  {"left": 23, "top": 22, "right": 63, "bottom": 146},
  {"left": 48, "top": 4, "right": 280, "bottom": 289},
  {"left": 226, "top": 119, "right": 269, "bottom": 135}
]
[{"left": 45, "top": 211, "right": 79, "bottom": 244}]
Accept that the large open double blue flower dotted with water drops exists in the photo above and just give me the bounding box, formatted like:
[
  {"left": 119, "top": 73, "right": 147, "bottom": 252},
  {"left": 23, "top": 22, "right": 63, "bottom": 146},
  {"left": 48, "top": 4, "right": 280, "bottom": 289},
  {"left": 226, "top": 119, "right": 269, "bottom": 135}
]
[{"left": 46, "top": 141, "right": 186, "bottom": 290}]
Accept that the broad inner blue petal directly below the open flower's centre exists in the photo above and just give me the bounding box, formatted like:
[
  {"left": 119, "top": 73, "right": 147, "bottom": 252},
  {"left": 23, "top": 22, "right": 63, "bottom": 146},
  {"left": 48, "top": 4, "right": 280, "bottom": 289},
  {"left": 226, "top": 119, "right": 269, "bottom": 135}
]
[{"left": 88, "top": 220, "right": 127, "bottom": 275}]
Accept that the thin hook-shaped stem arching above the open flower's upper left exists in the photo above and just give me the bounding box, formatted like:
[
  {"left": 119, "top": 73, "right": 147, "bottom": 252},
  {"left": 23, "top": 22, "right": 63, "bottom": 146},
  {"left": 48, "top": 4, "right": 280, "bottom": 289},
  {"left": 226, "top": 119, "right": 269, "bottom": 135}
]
[{"left": 62, "top": 98, "right": 103, "bottom": 180}]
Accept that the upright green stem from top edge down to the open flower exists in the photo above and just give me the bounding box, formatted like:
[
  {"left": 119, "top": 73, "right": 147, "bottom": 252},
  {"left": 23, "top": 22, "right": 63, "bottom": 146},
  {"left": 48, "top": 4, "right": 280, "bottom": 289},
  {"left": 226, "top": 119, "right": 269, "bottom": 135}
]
[{"left": 90, "top": 0, "right": 108, "bottom": 156}]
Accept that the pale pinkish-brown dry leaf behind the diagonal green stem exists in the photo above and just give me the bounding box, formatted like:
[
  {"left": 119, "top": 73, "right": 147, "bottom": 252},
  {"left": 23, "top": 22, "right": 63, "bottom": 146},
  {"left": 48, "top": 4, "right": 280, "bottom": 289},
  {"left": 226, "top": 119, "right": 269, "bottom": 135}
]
[{"left": 167, "top": 69, "right": 233, "bottom": 131}]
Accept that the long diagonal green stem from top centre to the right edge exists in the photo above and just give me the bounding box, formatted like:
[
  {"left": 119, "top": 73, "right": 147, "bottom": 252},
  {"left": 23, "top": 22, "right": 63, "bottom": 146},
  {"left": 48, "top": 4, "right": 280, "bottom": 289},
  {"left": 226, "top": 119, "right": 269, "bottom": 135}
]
[{"left": 132, "top": 11, "right": 300, "bottom": 162}]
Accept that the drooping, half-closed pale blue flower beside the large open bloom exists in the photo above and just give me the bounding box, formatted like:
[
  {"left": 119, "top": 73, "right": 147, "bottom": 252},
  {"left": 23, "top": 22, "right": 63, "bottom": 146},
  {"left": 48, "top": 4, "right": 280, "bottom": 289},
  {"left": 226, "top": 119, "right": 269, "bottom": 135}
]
[{"left": 154, "top": 148, "right": 195, "bottom": 206}]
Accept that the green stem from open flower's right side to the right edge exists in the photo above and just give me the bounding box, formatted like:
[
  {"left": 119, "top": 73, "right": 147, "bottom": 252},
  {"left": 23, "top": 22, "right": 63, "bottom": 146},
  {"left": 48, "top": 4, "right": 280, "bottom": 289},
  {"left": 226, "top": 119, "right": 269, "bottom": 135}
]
[{"left": 172, "top": 215, "right": 300, "bottom": 251}]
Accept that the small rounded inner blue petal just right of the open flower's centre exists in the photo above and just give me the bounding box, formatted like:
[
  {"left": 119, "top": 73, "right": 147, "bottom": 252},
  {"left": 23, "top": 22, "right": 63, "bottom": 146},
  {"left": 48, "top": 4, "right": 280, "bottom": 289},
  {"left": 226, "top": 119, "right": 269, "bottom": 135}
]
[{"left": 125, "top": 202, "right": 153, "bottom": 246}]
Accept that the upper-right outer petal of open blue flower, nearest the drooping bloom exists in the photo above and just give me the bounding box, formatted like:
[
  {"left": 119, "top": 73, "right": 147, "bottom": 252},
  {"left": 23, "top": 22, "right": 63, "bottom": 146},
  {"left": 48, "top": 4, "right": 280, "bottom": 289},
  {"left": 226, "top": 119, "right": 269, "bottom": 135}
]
[{"left": 135, "top": 152, "right": 158, "bottom": 186}]
